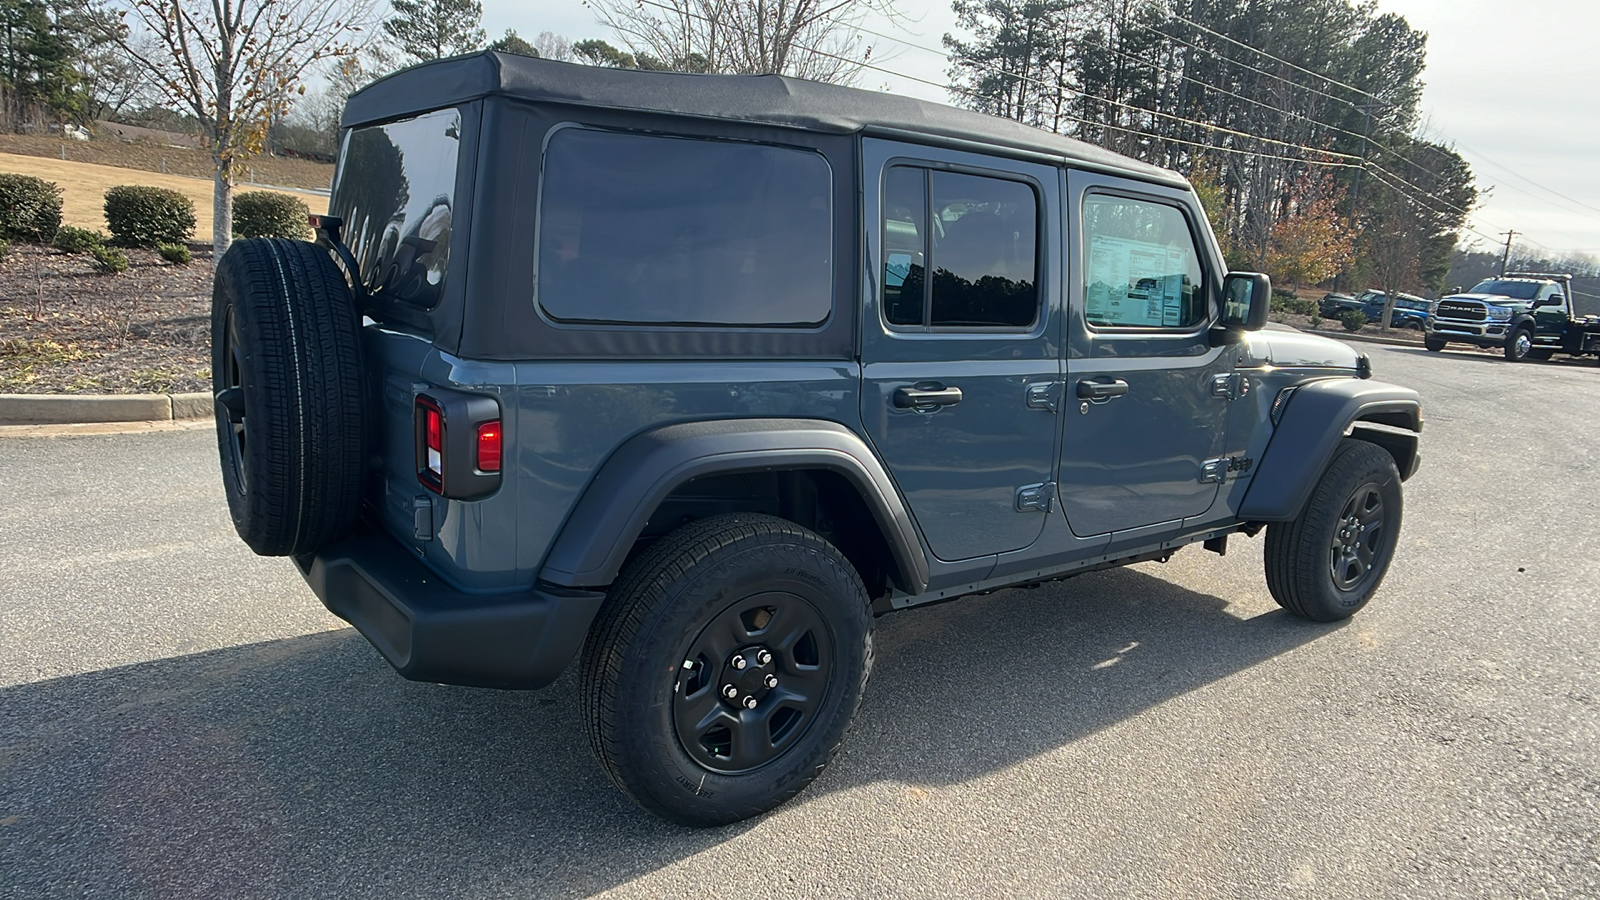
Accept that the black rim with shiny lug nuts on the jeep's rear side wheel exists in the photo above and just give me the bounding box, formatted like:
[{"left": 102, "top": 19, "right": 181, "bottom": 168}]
[{"left": 672, "top": 591, "right": 835, "bottom": 775}]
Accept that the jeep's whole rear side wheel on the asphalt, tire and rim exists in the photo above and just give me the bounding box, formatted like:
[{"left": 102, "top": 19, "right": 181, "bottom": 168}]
[{"left": 579, "top": 514, "right": 872, "bottom": 826}]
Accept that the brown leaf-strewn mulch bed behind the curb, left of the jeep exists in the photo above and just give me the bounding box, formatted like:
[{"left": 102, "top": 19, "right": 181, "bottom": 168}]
[{"left": 0, "top": 243, "right": 211, "bottom": 394}]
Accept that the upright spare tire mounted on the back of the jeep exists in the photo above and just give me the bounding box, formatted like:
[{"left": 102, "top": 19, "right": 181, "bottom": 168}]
[{"left": 211, "top": 239, "right": 366, "bottom": 556}]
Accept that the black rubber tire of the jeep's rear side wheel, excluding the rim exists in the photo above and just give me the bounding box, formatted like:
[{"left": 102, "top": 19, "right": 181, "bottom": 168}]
[{"left": 578, "top": 514, "right": 872, "bottom": 826}]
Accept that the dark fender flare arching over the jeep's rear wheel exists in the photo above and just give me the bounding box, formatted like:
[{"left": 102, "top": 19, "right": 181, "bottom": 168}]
[{"left": 539, "top": 418, "right": 928, "bottom": 594}]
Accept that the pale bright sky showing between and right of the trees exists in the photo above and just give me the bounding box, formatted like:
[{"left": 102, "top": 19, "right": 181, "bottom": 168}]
[{"left": 483, "top": 0, "right": 1600, "bottom": 256}]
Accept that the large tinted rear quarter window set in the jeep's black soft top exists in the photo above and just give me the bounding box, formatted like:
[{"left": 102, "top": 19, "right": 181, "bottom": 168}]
[{"left": 538, "top": 128, "right": 834, "bottom": 327}]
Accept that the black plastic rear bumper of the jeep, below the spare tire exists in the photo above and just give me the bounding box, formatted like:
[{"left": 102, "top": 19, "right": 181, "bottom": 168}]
[{"left": 294, "top": 532, "right": 605, "bottom": 687}]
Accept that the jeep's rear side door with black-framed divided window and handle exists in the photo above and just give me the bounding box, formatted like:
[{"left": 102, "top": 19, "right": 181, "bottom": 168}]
[{"left": 861, "top": 139, "right": 1061, "bottom": 560}]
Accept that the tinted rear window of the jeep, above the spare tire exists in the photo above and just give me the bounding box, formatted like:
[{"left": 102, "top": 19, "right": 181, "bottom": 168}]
[{"left": 331, "top": 109, "right": 461, "bottom": 307}]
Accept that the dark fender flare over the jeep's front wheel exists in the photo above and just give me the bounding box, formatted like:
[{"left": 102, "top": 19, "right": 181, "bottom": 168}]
[{"left": 1238, "top": 378, "right": 1422, "bottom": 522}]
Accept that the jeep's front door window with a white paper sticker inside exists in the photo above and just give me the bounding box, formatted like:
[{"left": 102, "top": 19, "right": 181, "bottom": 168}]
[{"left": 1083, "top": 194, "right": 1210, "bottom": 330}]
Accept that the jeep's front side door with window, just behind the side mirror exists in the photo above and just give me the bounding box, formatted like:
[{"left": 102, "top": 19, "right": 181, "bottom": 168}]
[{"left": 1059, "top": 171, "right": 1242, "bottom": 536}]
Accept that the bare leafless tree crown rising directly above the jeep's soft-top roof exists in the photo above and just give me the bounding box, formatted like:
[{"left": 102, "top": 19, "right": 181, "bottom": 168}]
[{"left": 594, "top": 0, "right": 896, "bottom": 83}]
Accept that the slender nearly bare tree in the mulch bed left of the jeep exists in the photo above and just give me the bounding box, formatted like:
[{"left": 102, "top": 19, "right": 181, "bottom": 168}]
[{"left": 106, "top": 0, "right": 371, "bottom": 248}]
